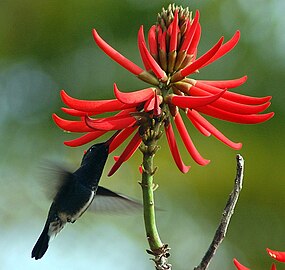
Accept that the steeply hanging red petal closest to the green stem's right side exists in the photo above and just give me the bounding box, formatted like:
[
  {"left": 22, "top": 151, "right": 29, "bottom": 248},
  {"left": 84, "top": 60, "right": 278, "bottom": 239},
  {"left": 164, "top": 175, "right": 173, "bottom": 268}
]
[{"left": 164, "top": 123, "right": 190, "bottom": 173}]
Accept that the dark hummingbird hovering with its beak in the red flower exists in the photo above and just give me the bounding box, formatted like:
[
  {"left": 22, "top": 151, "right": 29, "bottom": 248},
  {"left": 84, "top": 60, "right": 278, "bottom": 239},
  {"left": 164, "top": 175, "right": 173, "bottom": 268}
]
[{"left": 31, "top": 133, "right": 141, "bottom": 260}]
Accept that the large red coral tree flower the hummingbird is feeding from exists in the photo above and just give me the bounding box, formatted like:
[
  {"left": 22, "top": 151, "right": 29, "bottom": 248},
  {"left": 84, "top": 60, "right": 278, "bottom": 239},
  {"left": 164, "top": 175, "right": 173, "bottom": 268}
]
[{"left": 53, "top": 5, "right": 274, "bottom": 175}]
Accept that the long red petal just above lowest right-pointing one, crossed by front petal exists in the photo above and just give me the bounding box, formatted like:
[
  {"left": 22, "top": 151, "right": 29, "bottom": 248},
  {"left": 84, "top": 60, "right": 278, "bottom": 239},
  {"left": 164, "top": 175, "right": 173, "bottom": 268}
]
[{"left": 190, "top": 86, "right": 271, "bottom": 114}]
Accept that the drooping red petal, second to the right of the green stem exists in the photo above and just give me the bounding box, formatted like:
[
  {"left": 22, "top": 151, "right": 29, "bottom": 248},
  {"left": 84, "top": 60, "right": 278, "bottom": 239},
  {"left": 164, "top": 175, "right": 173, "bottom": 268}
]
[{"left": 174, "top": 112, "right": 210, "bottom": 166}]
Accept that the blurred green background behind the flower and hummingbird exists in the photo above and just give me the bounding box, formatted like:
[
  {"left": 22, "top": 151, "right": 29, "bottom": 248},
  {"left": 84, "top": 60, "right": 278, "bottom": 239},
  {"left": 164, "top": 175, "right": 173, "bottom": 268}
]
[{"left": 0, "top": 0, "right": 285, "bottom": 270}]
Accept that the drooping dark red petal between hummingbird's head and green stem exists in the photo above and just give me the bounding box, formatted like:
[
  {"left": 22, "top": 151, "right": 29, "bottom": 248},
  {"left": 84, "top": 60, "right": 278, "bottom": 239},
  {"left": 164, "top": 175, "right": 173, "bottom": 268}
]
[{"left": 108, "top": 132, "right": 142, "bottom": 176}]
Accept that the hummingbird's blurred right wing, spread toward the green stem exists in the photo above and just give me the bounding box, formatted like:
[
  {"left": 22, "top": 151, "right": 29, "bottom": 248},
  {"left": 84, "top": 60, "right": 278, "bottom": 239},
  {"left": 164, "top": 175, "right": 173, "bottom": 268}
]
[{"left": 89, "top": 186, "right": 143, "bottom": 214}]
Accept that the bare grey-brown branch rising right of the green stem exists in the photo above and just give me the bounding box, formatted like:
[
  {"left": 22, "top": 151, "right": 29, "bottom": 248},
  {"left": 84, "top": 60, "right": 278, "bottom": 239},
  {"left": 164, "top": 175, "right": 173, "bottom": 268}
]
[{"left": 194, "top": 154, "right": 244, "bottom": 270}]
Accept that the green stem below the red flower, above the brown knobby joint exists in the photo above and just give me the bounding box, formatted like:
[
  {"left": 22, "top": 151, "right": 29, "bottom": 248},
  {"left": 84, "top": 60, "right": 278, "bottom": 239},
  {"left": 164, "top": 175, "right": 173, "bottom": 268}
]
[{"left": 141, "top": 151, "right": 163, "bottom": 252}]
